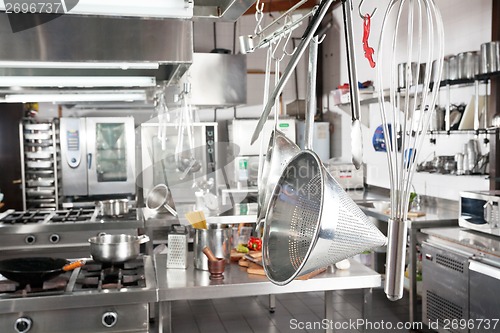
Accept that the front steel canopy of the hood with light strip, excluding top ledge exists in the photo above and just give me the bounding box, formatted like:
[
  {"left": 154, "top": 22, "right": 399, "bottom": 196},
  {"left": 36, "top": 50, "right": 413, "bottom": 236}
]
[{"left": 0, "top": 13, "right": 193, "bottom": 101}]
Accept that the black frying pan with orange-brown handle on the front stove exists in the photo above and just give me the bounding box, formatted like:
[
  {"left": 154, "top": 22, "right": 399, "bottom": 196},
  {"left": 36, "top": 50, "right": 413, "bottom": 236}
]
[{"left": 0, "top": 257, "right": 85, "bottom": 287}]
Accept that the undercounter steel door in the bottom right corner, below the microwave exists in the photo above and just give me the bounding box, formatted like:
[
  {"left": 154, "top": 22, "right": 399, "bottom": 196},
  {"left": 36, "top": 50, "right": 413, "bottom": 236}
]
[{"left": 469, "top": 260, "right": 500, "bottom": 333}]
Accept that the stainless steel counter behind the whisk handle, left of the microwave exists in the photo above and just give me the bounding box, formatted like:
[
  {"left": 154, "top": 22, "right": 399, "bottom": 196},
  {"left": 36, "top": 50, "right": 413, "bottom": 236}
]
[{"left": 348, "top": 189, "right": 459, "bottom": 322}]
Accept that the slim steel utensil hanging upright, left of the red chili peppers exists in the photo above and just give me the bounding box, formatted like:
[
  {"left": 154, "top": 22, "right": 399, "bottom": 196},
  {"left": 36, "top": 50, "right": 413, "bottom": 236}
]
[{"left": 342, "top": 0, "right": 363, "bottom": 169}]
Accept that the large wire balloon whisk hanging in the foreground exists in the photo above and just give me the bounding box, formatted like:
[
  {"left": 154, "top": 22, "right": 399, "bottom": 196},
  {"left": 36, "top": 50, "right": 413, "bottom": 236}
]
[{"left": 377, "top": 0, "right": 444, "bottom": 300}]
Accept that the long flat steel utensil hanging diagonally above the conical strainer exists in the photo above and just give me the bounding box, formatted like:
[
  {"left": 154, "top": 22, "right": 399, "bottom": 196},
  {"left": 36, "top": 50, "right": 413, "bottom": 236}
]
[{"left": 251, "top": 0, "right": 333, "bottom": 144}]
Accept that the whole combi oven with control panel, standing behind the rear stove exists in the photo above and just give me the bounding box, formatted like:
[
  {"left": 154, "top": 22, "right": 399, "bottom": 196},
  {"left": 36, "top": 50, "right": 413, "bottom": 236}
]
[{"left": 60, "top": 117, "right": 135, "bottom": 196}]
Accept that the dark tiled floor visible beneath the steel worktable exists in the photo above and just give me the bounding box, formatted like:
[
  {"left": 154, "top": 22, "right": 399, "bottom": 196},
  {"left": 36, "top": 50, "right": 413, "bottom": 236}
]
[{"left": 167, "top": 289, "right": 422, "bottom": 333}]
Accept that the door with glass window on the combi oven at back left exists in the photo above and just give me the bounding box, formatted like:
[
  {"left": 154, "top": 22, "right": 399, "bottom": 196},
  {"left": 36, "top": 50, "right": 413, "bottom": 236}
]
[{"left": 87, "top": 117, "right": 135, "bottom": 195}]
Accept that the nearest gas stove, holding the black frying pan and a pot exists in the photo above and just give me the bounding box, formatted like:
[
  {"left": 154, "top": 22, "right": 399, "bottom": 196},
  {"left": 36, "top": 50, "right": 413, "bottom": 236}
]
[{"left": 0, "top": 256, "right": 157, "bottom": 333}]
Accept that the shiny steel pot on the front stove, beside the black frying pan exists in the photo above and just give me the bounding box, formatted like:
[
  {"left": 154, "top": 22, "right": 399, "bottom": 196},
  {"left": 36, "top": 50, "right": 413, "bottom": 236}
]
[{"left": 89, "top": 234, "right": 149, "bottom": 263}]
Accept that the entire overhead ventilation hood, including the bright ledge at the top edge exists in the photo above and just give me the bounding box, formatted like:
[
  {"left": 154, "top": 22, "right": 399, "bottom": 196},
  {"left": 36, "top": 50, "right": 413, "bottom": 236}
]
[{"left": 0, "top": 0, "right": 255, "bottom": 102}]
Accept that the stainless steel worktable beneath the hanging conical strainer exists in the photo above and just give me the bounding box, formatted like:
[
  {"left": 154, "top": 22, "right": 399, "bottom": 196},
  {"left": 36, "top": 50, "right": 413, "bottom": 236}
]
[{"left": 155, "top": 255, "right": 381, "bottom": 332}]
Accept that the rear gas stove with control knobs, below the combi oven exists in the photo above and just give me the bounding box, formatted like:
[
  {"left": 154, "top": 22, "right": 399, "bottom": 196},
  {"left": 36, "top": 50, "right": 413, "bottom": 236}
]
[{"left": 0, "top": 208, "right": 144, "bottom": 258}]
